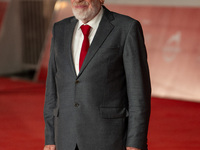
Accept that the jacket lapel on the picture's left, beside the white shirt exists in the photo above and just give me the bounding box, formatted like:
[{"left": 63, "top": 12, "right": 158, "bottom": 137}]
[{"left": 64, "top": 18, "right": 78, "bottom": 77}]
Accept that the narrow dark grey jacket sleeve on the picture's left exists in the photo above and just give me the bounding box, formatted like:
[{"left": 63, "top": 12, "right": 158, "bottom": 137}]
[{"left": 44, "top": 25, "right": 57, "bottom": 145}]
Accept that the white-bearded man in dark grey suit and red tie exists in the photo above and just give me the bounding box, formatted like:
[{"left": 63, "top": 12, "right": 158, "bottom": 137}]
[{"left": 44, "top": 0, "right": 151, "bottom": 150}]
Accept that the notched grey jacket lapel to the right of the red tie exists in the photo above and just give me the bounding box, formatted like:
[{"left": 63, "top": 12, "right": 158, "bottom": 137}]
[{"left": 77, "top": 7, "right": 114, "bottom": 78}]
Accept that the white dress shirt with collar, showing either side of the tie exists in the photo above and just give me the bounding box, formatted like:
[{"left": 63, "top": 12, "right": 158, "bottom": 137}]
[{"left": 72, "top": 7, "right": 103, "bottom": 75}]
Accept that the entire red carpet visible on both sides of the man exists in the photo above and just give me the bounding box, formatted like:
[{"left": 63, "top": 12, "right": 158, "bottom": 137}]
[{"left": 0, "top": 78, "right": 200, "bottom": 150}]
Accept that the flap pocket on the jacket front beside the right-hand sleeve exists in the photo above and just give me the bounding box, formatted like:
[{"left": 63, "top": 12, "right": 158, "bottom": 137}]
[{"left": 100, "top": 107, "right": 128, "bottom": 119}]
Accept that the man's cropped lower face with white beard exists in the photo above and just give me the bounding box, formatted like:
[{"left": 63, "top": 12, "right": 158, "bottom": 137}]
[{"left": 71, "top": 0, "right": 103, "bottom": 23}]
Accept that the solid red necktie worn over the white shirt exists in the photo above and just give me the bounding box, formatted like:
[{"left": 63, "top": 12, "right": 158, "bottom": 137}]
[{"left": 79, "top": 25, "right": 90, "bottom": 70}]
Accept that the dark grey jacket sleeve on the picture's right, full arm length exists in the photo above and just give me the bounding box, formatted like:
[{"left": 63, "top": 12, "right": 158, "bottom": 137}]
[{"left": 123, "top": 20, "right": 151, "bottom": 150}]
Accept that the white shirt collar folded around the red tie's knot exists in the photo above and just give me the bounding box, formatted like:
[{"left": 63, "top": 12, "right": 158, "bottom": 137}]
[{"left": 78, "top": 7, "right": 104, "bottom": 29}]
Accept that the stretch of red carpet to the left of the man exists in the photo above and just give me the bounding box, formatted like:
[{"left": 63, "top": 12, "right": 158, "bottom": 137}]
[{"left": 0, "top": 79, "right": 45, "bottom": 150}]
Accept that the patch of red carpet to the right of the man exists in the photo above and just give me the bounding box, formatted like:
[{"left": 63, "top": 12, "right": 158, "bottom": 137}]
[{"left": 149, "top": 98, "right": 200, "bottom": 150}]
